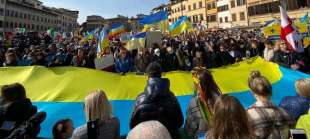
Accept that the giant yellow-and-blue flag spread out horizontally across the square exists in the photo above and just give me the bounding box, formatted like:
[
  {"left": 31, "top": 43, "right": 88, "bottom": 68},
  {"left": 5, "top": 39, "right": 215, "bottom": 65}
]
[{"left": 0, "top": 58, "right": 310, "bottom": 138}]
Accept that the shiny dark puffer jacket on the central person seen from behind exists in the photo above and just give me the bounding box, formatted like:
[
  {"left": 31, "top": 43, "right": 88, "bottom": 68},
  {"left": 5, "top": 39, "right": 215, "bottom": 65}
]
[{"left": 130, "top": 78, "right": 184, "bottom": 138}]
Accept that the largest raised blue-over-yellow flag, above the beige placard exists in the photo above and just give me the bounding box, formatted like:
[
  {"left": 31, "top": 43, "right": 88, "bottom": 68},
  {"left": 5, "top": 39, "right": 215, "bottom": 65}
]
[{"left": 139, "top": 11, "right": 169, "bottom": 31}]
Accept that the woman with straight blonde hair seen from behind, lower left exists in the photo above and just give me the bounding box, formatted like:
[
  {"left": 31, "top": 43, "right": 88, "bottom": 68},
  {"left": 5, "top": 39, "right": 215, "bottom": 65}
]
[{"left": 73, "top": 90, "right": 120, "bottom": 139}]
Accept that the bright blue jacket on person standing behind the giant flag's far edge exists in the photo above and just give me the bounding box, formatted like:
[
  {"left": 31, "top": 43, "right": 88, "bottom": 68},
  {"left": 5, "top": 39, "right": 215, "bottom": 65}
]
[{"left": 115, "top": 56, "right": 133, "bottom": 73}]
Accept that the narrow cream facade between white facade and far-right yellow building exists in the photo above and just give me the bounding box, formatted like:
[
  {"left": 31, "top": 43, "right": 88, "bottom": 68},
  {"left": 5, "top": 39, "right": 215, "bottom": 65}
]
[{"left": 230, "top": 0, "right": 248, "bottom": 27}]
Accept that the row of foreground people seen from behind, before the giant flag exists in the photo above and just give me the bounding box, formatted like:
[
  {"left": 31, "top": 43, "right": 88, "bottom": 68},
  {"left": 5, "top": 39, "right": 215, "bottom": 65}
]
[{"left": 0, "top": 62, "right": 310, "bottom": 139}]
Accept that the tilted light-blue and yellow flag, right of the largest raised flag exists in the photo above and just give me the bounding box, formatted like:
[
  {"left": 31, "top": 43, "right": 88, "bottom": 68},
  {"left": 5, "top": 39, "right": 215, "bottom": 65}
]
[{"left": 169, "top": 16, "right": 193, "bottom": 36}]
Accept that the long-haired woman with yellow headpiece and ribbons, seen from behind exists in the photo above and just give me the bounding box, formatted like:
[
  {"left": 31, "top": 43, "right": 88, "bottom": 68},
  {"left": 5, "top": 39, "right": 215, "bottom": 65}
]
[{"left": 185, "top": 67, "right": 222, "bottom": 137}]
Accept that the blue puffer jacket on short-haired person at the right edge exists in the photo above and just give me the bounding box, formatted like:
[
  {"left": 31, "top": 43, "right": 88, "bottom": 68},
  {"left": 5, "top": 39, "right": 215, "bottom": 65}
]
[{"left": 280, "top": 95, "right": 310, "bottom": 121}]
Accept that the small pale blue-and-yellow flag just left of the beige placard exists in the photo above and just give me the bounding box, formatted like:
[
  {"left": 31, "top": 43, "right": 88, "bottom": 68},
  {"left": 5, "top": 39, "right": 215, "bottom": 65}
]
[{"left": 125, "top": 32, "right": 146, "bottom": 50}]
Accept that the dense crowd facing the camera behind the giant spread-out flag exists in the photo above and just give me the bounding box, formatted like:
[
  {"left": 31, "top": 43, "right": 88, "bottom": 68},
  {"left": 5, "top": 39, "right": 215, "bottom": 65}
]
[{"left": 0, "top": 30, "right": 310, "bottom": 74}]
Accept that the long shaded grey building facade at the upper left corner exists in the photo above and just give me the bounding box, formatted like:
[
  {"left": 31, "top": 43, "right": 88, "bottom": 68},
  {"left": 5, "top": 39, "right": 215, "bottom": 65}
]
[{"left": 0, "top": 0, "right": 79, "bottom": 32}]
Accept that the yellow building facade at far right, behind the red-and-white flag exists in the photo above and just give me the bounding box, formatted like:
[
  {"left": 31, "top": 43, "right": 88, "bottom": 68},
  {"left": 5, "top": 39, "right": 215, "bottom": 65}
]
[{"left": 247, "top": 0, "right": 310, "bottom": 26}]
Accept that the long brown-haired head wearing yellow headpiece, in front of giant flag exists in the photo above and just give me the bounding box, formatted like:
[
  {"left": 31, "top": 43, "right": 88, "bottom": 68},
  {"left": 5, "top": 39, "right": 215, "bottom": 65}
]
[{"left": 192, "top": 67, "right": 221, "bottom": 100}]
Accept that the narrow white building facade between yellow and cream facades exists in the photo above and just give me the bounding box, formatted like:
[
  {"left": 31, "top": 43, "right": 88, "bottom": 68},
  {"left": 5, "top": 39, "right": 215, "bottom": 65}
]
[{"left": 216, "top": 0, "right": 232, "bottom": 29}]
